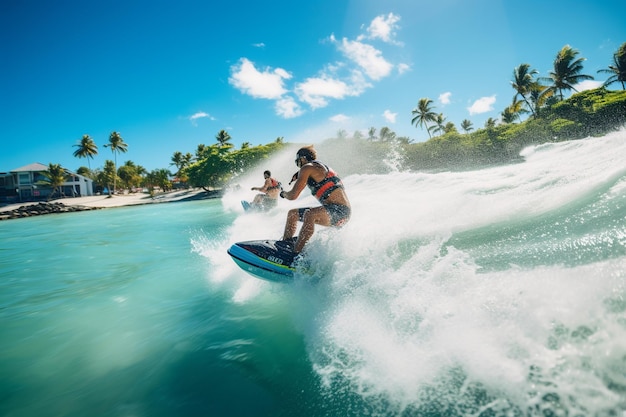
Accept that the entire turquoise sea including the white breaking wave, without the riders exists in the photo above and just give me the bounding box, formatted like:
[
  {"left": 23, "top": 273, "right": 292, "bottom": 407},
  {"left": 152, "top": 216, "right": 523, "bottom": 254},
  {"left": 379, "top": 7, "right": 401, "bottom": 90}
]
[{"left": 0, "top": 131, "right": 626, "bottom": 417}]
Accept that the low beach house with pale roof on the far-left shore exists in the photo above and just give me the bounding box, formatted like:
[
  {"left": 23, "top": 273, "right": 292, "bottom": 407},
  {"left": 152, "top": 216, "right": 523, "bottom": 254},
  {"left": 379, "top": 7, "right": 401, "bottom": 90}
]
[{"left": 0, "top": 162, "right": 94, "bottom": 204}]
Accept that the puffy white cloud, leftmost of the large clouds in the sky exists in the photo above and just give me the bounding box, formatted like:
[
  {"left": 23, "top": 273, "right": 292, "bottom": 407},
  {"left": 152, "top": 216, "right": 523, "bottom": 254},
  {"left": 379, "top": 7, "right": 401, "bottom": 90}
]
[{"left": 228, "top": 58, "right": 291, "bottom": 99}]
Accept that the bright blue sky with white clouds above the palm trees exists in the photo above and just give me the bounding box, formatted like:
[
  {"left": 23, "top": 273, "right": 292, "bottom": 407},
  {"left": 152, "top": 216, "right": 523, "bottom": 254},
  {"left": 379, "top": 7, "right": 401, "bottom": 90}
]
[{"left": 0, "top": 0, "right": 626, "bottom": 172}]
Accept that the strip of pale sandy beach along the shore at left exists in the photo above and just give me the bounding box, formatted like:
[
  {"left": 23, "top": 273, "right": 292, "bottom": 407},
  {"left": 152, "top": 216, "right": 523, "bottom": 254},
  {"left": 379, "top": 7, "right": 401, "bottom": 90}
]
[{"left": 0, "top": 189, "right": 220, "bottom": 213}]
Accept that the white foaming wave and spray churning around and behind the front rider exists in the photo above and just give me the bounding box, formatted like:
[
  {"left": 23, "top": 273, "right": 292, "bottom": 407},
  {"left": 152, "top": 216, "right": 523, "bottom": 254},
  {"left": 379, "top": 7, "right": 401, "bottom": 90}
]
[{"left": 209, "top": 131, "right": 626, "bottom": 415}]
